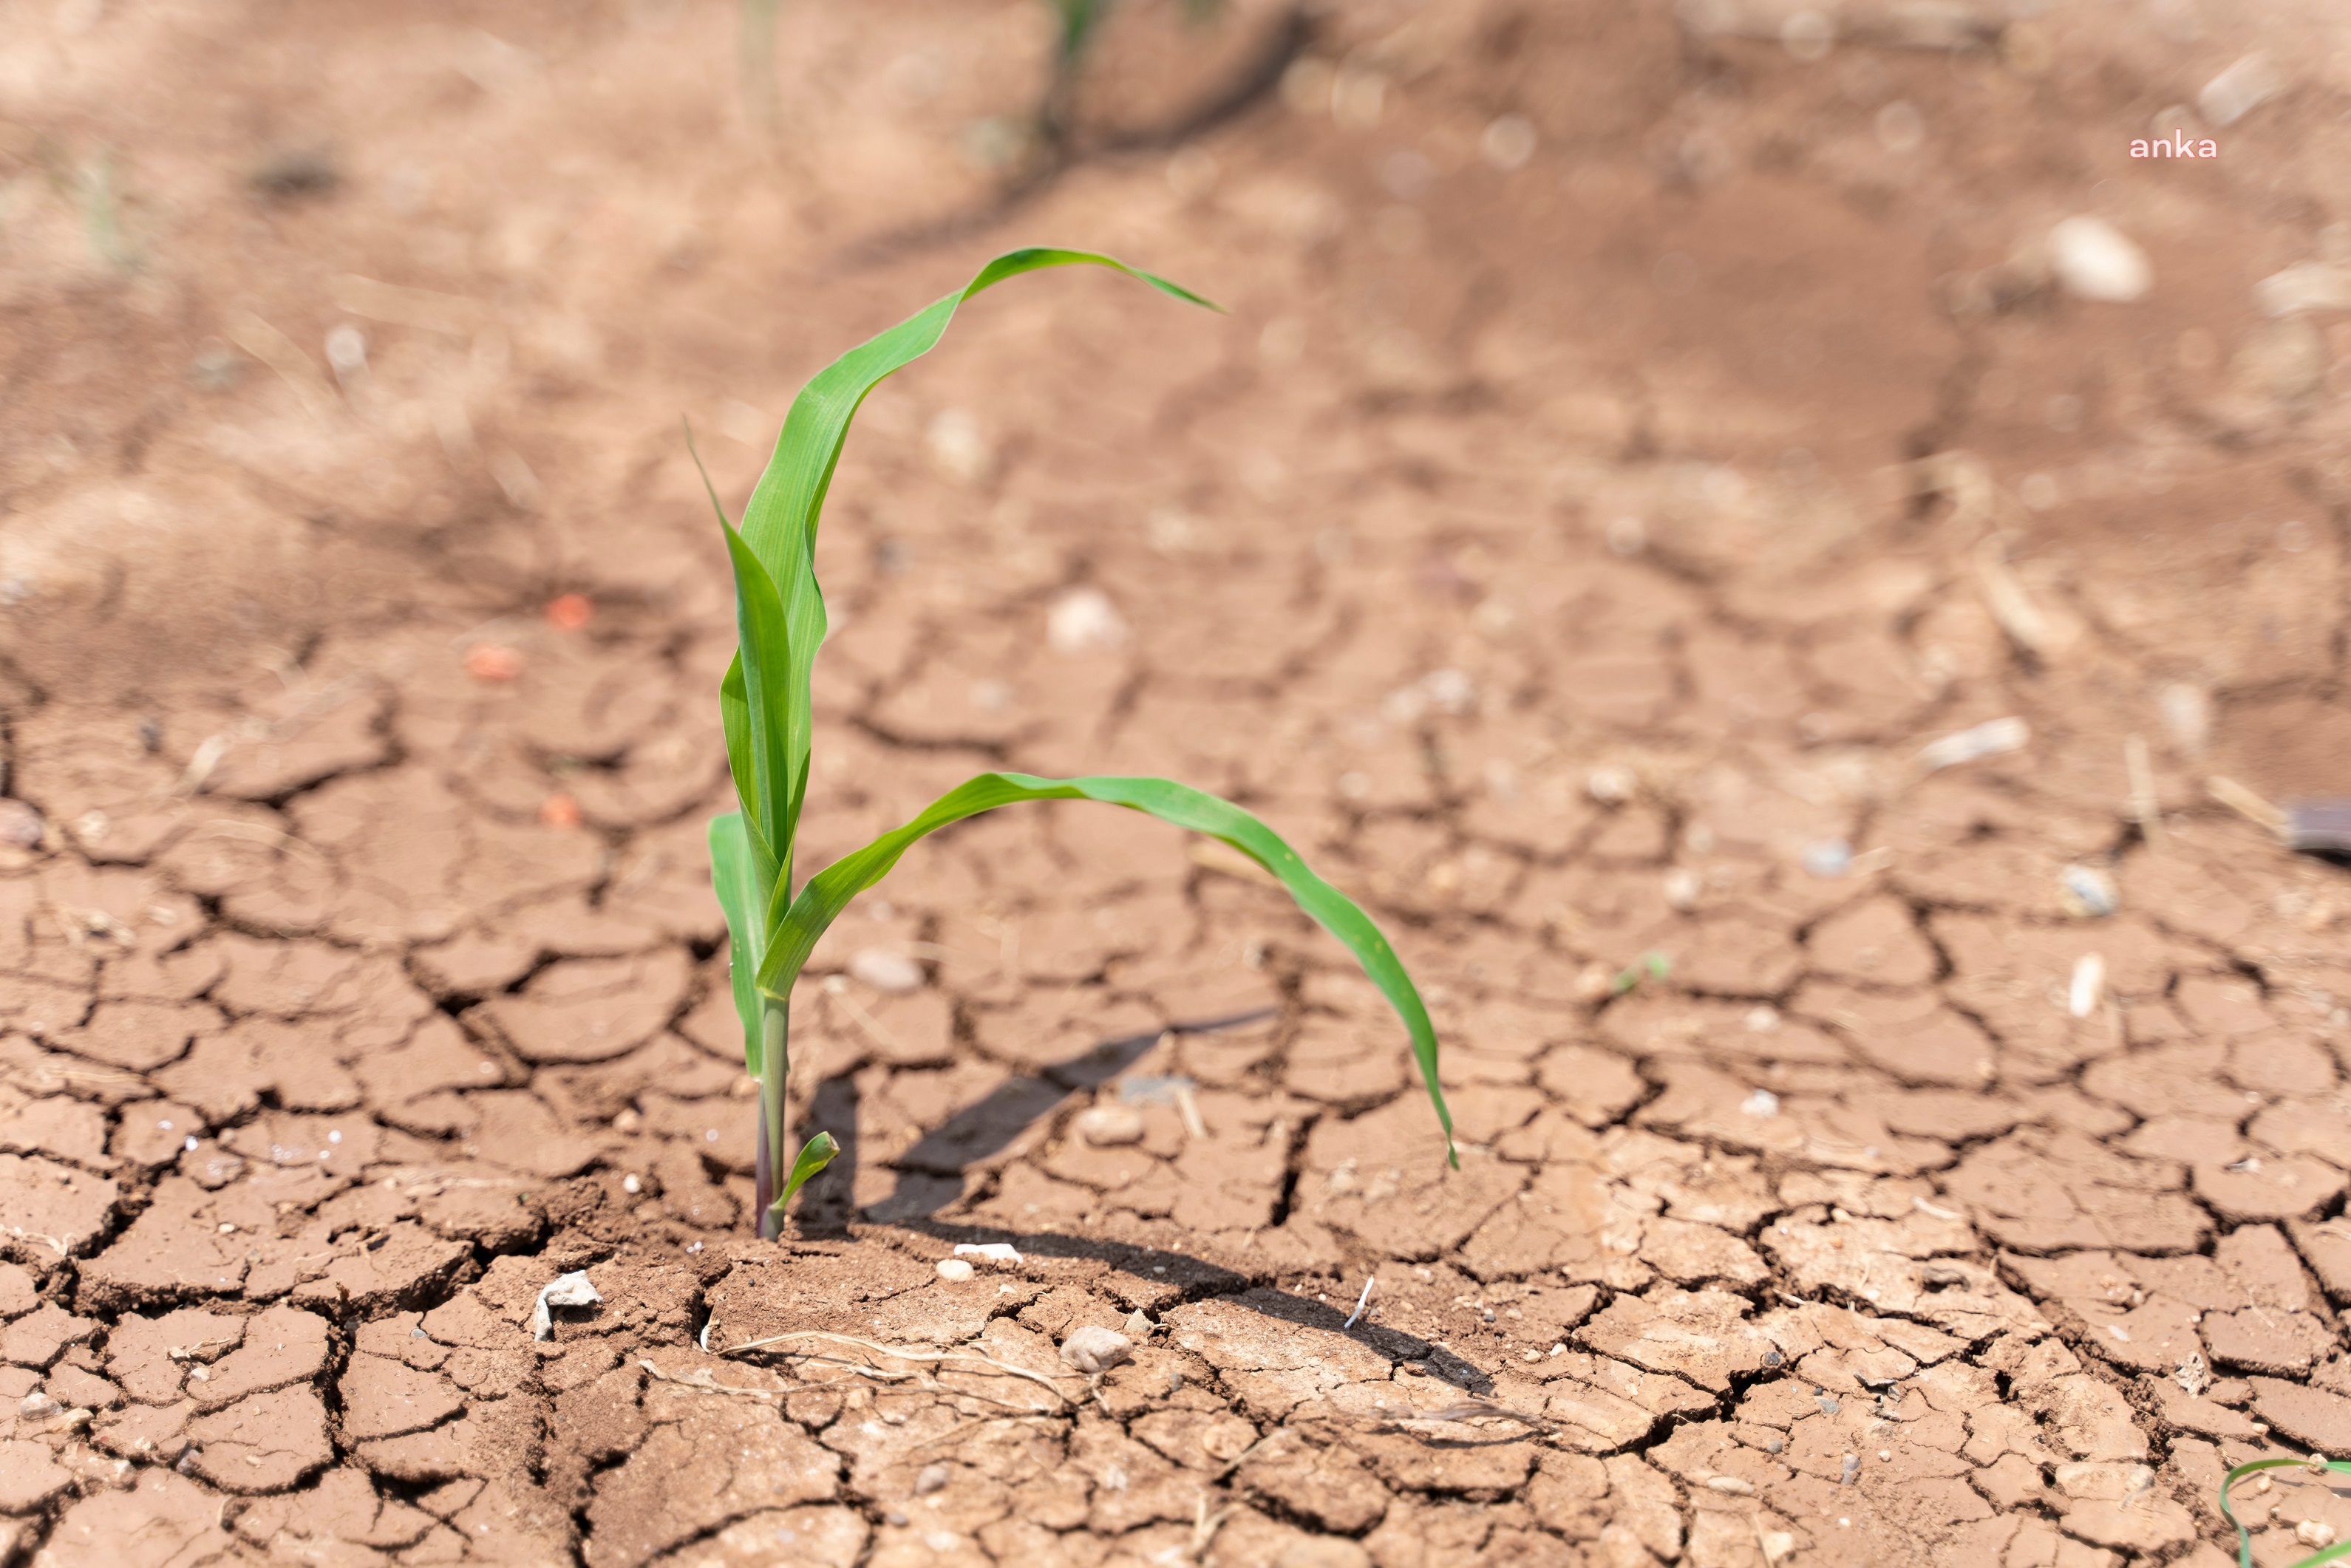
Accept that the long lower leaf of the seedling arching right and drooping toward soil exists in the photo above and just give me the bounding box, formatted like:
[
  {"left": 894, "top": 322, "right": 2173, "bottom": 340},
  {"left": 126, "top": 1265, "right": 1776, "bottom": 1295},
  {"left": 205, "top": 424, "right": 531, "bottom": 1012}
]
[{"left": 759, "top": 774, "right": 1460, "bottom": 1166}]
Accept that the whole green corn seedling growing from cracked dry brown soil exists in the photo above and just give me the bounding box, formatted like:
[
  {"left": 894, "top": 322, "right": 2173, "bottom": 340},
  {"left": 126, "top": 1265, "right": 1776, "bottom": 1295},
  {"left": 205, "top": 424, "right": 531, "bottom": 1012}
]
[{"left": 705, "top": 249, "right": 1457, "bottom": 1236}]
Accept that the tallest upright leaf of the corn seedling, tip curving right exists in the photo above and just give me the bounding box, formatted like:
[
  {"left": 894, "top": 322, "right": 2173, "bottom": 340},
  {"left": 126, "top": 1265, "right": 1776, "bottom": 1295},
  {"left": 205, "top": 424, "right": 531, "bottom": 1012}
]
[{"left": 719, "top": 249, "right": 1216, "bottom": 919}]
